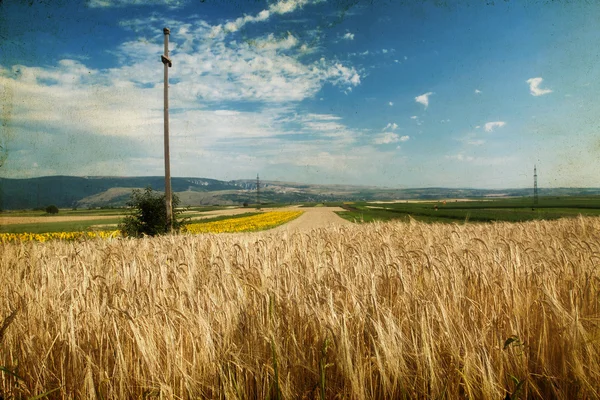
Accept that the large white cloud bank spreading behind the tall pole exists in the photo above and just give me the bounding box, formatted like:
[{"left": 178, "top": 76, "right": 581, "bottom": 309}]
[{"left": 0, "top": 6, "right": 376, "bottom": 179}]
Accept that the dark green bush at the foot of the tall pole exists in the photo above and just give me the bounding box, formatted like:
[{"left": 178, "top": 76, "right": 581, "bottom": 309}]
[{"left": 119, "top": 187, "right": 186, "bottom": 237}]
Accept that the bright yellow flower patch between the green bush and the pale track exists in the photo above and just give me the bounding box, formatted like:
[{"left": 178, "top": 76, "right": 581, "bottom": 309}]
[{"left": 183, "top": 211, "right": 302, "bottom": 233}]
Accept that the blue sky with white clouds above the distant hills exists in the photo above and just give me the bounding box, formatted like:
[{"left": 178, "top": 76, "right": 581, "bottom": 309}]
[{"left": 0, "top": 0, "right": 600, "bottom": 188}]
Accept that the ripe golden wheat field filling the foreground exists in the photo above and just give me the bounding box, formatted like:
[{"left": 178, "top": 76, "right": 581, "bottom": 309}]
[{"left": 0, "top": 218, "right": 600, "bottom": 400}]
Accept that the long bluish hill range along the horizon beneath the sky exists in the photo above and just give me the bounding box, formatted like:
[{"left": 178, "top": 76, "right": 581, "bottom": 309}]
[{"left": 0, "top": 176, "right": 600, "bottom": 210}]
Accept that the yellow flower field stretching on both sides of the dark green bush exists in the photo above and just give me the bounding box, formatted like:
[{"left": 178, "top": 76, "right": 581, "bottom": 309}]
[{"left": 0, "top": 211, "right": 302, "bottom": 243}]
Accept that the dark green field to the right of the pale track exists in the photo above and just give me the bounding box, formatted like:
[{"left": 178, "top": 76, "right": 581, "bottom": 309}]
[{"left": 338, "top": 197, "right": 600, "bottom": 223}]
